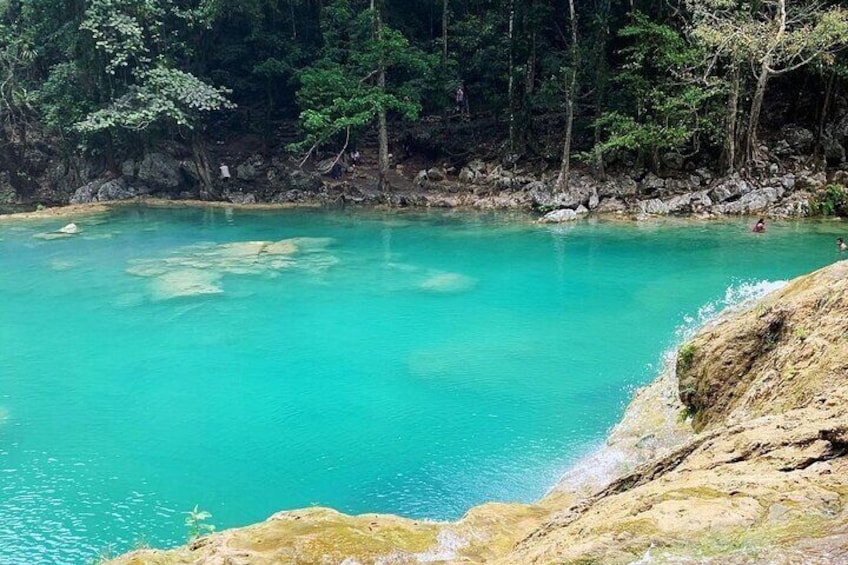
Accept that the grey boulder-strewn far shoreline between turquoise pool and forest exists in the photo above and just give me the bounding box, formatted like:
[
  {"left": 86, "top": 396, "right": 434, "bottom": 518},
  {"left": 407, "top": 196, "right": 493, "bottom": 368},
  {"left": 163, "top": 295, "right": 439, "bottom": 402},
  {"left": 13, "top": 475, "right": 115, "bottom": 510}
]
[{"left": 6, "top": 133, "right": 848, "bottom": 222}]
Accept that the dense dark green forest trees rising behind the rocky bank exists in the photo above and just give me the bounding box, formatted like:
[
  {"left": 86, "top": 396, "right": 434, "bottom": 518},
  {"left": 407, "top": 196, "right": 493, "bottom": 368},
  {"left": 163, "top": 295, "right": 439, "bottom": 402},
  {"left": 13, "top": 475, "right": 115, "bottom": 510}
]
[{"left": 0, "top": 0, "right": 848, "bottom": 186}]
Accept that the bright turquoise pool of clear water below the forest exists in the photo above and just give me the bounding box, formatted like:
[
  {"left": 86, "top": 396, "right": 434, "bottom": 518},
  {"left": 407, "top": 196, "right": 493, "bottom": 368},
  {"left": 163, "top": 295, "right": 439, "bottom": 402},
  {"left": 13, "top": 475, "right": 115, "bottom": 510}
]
[{"left": 0, "top": 208, "right": 843, "bottom": 564}]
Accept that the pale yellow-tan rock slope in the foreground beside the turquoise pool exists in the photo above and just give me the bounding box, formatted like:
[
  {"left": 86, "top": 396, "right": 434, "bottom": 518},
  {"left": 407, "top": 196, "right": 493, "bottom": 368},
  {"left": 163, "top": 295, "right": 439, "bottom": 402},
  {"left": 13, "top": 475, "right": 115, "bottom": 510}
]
[{"left": 109, "top": 262, "right": 848, "bottom": 565}]
